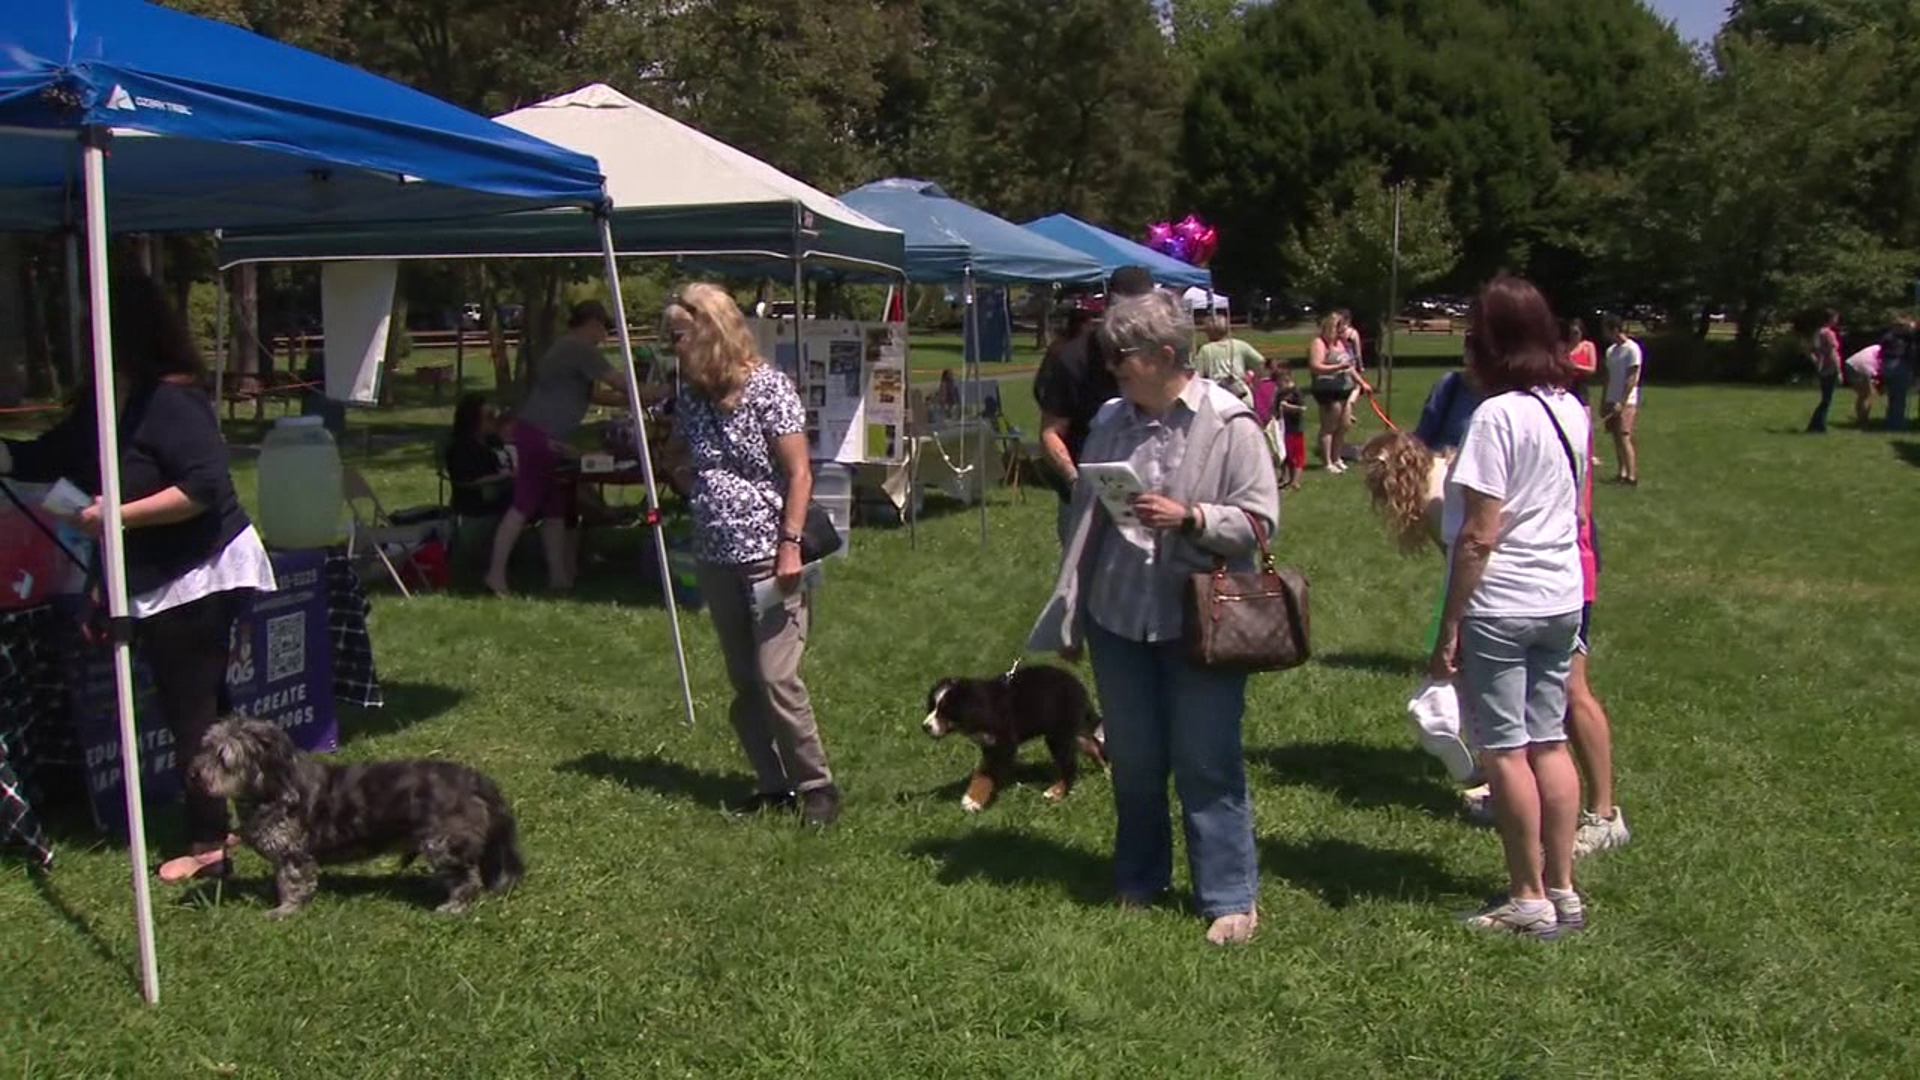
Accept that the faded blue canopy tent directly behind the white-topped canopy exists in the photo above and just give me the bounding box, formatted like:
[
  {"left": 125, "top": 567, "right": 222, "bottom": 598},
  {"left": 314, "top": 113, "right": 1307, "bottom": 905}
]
[{"left": 841, "top": 179, "right": 1106, "bottom": 546}]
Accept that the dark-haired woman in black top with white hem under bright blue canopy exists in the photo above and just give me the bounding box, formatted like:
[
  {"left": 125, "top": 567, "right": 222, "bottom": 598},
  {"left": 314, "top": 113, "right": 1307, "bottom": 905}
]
[{"left": 0, "top": 277, "right": 275, "bottom": 880}]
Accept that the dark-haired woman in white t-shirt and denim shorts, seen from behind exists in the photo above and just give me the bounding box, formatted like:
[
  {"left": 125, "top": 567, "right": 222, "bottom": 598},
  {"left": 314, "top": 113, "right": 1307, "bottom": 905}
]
[{"left": 1430, "top": 277, "right": 1590, "bottom": 938}]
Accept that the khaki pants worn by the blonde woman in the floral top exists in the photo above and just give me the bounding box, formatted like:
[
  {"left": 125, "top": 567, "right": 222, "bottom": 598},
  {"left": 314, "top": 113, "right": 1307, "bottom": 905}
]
[{"left": 699, "top": 561, "right": 833, "bottom": 794}]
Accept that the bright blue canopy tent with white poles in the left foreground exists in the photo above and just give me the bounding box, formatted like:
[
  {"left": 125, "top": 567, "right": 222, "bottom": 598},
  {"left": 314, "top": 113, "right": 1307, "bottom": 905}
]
[{"left": 0, "top": 0, "right": 706, "bottom": 1001}]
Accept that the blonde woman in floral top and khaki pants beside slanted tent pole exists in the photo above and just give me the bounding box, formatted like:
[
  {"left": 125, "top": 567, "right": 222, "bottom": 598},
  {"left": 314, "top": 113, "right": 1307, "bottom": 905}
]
[{"left": 666, "top": 284, "right": 841, "bottom": 824}]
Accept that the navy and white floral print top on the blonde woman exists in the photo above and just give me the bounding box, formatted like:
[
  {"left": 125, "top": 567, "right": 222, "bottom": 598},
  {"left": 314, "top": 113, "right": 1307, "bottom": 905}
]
[{"left": 674, "top": 363, "right": 806, "bottom": 567}]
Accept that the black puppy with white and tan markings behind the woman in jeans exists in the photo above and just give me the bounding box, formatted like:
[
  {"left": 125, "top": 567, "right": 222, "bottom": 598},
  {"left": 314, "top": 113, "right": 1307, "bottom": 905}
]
[{"left": 920, "top": 667, "right": 1106, "bottom": 813}]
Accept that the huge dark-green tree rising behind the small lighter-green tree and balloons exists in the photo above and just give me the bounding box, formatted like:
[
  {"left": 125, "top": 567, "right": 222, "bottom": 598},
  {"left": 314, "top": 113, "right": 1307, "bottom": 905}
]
[{"left": 1183, "top": 0, "right": 1688, "bottom": 303}]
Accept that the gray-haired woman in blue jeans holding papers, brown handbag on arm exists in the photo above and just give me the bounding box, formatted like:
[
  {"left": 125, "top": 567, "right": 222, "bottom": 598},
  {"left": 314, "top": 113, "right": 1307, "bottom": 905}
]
[{"left": 1027, "top": 292, "right": 1281, "bottom": 944}]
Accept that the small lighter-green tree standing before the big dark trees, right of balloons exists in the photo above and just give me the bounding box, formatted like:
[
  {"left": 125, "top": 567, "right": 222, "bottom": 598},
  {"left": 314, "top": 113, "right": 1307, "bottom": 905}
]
[{"left": 1288, "top": 165, "right": 1459, "bottom": 340}]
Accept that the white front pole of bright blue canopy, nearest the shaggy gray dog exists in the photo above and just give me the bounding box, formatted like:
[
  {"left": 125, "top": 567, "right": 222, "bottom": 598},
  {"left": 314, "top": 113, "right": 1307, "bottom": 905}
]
[{"left": 81, "top": 127, "right": 161, "bottom": 1005}]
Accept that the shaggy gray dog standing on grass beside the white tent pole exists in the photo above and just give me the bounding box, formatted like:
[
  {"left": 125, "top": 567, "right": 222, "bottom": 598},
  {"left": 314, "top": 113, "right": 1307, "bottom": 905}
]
[{"left": 188, "top": 719, "right": 524, "bottom": 919}]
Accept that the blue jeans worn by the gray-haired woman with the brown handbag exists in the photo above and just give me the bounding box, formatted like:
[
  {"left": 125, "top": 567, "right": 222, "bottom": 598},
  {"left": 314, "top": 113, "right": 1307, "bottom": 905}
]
[{"left": 1087, "top": 619, "right": 1260, "bottom": 919}]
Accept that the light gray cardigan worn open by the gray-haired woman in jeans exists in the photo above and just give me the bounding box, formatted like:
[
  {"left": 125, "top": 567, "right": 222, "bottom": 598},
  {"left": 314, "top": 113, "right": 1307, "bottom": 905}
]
[{"left": 1027, "top": 382, "right": 1281, "bottom": 651}]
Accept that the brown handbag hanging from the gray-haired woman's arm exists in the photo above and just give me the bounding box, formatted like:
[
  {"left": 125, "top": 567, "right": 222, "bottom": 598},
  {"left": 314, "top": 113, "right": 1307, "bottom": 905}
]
[{"left": 1187, "top": 513, "right": 1311, "bottom": 673}]
